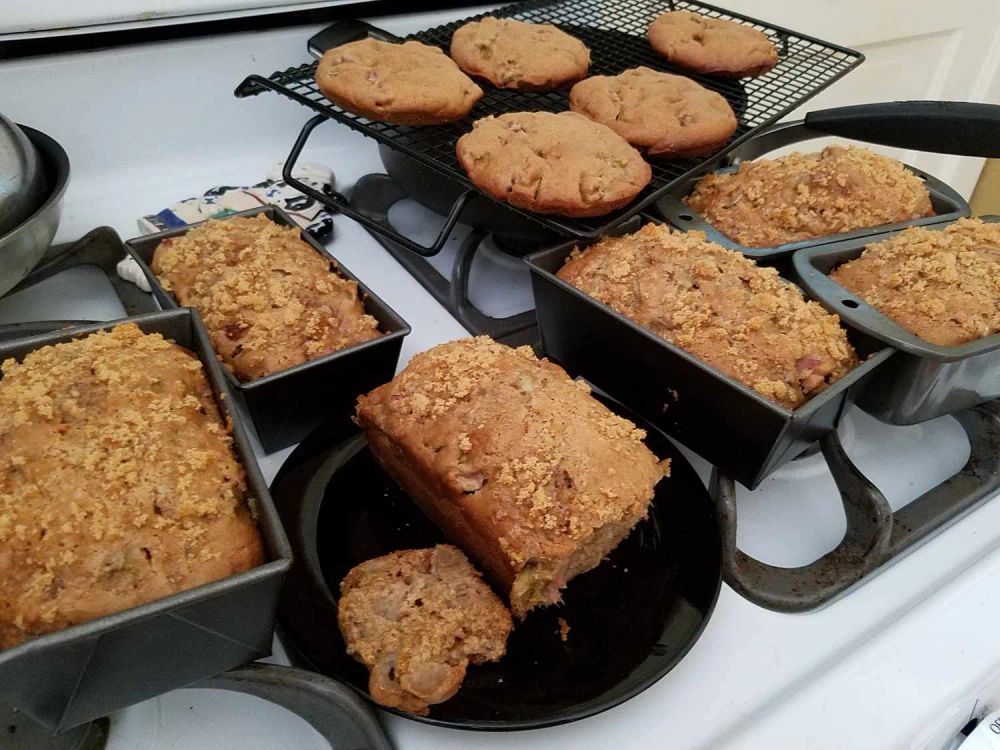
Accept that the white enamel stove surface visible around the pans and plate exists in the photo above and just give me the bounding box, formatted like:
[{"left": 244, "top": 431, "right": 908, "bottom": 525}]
[{"left": 0, "top": 10, "right": 1000, "bottom": 750}]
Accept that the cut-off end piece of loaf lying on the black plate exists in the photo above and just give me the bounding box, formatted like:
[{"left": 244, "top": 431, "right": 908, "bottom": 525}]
[{"left": 337, "top": 544, "right": 512, "bottom": 716}]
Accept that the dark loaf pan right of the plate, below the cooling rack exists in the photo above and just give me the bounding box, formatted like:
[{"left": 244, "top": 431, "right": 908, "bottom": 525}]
[{"left": 526, "top": 232, "right": 893, "bottom": 489}]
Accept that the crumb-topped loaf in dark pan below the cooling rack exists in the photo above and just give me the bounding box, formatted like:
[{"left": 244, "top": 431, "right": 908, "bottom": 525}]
[{"left": 558, "top": 224, "right": 858, "bottom": 409}]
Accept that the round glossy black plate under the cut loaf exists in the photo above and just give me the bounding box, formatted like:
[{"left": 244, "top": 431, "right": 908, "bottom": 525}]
[{"left": 272, "top": 404, "right": 722, "bottom": 730}]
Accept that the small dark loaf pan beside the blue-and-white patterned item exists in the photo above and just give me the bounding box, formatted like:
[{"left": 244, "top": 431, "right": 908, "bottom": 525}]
[{"left": 125, "top": 206, "right": 410, "bottom": 453}]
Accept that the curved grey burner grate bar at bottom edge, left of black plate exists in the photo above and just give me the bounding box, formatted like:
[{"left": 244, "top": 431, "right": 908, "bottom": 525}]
[{"left": 190, "top": 664, "right": 392, "bottom": 750}]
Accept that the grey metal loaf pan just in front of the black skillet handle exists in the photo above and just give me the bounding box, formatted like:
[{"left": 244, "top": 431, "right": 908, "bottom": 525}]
[{"left": 656, "top": 121, "right": 972, "bottom": 263}]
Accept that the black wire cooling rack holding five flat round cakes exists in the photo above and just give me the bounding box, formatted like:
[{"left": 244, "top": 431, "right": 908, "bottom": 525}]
[{"left": 236, "top": 0, "right": 864, "bottom": 238}]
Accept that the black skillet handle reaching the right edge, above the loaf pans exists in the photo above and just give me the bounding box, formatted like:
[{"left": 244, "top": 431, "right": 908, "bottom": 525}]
[{"left": 805, "top": 101, "right": 1000, "bottom": 158}]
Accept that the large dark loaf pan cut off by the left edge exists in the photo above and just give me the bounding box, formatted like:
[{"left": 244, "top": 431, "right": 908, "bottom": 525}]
[{"left": 0, "top": 309, "right": 292, "bottom": 732}]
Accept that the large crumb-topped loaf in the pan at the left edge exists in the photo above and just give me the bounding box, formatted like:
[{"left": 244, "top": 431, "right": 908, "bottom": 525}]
[{"left": 0, "top": 323, "right": 263, "bottom": 648}]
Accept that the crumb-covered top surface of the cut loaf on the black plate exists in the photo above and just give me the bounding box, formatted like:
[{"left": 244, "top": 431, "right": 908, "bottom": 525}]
[{"left": 358, "top": 336, "right": 668, "bottom": 563}]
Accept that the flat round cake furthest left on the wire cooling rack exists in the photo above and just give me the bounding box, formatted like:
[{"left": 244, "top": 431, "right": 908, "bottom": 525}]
[{"left": 316, "top": 39, "right": 483, "bottom": 125}]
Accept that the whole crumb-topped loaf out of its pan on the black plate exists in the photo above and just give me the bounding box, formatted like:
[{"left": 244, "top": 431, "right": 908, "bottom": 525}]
[{"left": 357, "top": 336, "right": 667, "bottom": 618}]
